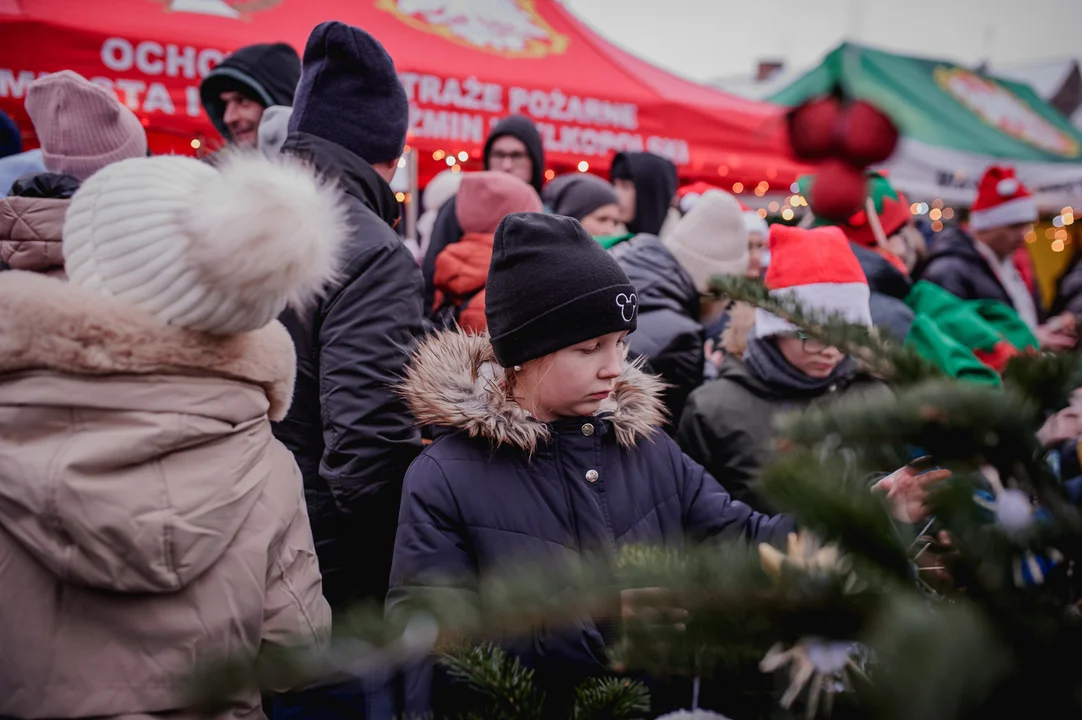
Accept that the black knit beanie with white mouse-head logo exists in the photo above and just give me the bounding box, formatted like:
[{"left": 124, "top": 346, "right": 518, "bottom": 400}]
[{"left": 485, "top": 212, "right": 638, "bottom": 367}]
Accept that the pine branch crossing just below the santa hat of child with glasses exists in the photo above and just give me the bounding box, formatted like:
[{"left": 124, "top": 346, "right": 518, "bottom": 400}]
[{"left": 710, "top": 276, "right": 942, "bottom": 385}]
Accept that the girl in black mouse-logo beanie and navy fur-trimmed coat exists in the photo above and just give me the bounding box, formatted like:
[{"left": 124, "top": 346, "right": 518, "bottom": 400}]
[{"left": 387, "top": 213, "right": 939, "bottom": 717}]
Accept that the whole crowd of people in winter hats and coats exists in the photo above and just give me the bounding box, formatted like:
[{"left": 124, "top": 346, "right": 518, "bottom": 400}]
[{"left": 0, "top": 15, "right": 1082, "bottom": 718}]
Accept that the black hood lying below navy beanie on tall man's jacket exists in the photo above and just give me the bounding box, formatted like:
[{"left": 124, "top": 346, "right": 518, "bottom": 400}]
[{"left": 281, "top": 132, "right": 399, "bottom": 227}]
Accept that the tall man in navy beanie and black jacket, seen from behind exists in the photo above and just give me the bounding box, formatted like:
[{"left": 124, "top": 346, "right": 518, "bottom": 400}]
[{"left": 275, "top": 22, "right": 421, "bottom": 612}]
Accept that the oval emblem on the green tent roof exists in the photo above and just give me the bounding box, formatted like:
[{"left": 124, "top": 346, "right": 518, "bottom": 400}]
[{"left": 935, "top": 67, "right": 1082, "bottom": 157}]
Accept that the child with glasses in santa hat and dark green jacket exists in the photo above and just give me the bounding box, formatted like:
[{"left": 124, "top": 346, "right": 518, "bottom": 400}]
[{"left": 676, "top": 225, "right": 889, "bottom": 510}]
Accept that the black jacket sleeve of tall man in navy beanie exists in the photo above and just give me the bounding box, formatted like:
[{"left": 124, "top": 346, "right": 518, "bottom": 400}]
[{"left": 319, "top": 245, "right": 421, "bottom": 517}]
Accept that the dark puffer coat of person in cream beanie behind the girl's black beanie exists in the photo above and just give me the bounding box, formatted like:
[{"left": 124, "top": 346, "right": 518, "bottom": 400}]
[{"left": 612, "top": 235, "right": 705, "bottom": 424}]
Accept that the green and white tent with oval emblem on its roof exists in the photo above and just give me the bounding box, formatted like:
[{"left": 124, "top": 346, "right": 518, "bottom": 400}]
[{"left": 769, "top": 43, "right": 1082, "bottom": 212}]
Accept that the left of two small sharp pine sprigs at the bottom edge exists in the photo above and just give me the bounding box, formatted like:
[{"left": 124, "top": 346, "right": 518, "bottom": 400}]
[{"left": 441, "top": 644, "right": 544, "bottom": 720}]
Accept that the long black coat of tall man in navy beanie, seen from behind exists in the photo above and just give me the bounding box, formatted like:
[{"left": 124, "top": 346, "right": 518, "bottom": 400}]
[{"left": 275, "top": 133, "right": 421, "bottom": 611}]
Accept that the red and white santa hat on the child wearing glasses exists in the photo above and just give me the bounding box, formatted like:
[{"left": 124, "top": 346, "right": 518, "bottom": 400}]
[{"left": 755, "top": 225, "right": 872, "bottom": 338}]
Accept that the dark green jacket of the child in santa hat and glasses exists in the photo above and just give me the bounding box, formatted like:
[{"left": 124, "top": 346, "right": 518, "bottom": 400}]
[{"left": 676, "top": 356, "right": 889, "bottom": 511}]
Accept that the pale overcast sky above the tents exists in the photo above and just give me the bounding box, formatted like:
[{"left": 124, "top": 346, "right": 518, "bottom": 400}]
[{"left": 563, "top": 0, "right": 1082, "bottom": 80}]
